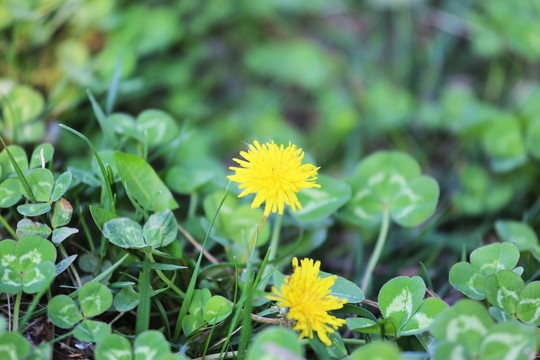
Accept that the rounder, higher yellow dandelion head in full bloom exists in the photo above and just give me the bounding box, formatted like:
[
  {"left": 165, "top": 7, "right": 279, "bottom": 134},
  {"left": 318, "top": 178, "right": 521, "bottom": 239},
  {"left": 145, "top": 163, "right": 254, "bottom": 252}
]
[{"left": 228, "top": 141, "right": 321, "bottom": 216}]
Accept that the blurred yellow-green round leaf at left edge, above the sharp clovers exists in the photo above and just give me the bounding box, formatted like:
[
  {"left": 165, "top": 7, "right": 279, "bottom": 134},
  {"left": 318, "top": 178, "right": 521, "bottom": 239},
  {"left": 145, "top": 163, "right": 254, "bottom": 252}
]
[{"left": 2, "top": 85, "right": 45, "bottom": 125}]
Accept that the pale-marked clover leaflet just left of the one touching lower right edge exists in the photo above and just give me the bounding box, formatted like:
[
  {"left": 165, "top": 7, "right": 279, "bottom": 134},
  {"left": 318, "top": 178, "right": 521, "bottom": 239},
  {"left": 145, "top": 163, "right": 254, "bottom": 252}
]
[{"left": 484, "top": 270, "right": 525, "bottom": 314}]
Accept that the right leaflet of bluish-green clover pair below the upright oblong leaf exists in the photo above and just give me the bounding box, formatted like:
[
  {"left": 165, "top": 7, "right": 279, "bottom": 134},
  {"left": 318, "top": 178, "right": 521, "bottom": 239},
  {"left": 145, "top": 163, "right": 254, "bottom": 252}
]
[{"left": 143, "top": 209, "right": 178, "bottom": 249}]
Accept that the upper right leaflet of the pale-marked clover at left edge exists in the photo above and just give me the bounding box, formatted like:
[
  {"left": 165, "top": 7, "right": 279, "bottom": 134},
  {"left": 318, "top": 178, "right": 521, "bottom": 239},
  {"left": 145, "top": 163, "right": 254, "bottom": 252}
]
[{"left": 15, "top": 235, "right": 56, "bottom": 271}]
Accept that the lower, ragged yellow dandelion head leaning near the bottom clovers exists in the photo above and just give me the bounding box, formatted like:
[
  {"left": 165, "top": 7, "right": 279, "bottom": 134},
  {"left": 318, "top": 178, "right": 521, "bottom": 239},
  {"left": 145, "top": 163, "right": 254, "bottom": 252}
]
[{"left": 268, "top": 258, "right": 347, "bottom": 346}]
